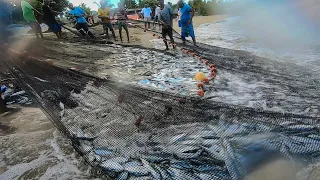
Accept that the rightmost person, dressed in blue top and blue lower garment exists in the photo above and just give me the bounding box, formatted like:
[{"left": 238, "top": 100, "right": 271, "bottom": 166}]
[{"left": 178, "top": 0, "right": 196, "bottom": 45}]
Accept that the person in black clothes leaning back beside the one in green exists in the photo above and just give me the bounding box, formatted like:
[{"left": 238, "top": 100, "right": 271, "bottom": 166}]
[{"left": 42, "top": 0, "right": 62, "bottom": 39}]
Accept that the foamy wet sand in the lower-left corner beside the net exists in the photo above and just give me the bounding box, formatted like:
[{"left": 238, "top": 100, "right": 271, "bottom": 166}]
[{"left": 0, "top": 107, "right": 96, "bottom": 180}]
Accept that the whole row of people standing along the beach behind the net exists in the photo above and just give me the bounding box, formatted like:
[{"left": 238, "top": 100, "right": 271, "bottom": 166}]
[{"left": 2, "top": 0, "right": 196, "bottom": 49}]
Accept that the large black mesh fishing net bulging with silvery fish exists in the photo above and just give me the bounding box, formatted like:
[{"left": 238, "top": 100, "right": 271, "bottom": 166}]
[{"left": 0, "top": 23, "right": 320, "bottom": 180}]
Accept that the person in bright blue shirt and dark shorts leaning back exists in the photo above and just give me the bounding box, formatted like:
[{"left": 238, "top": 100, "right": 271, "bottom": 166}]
[{"left": 69, "top": 3, "right": 96, "bottom": 39}]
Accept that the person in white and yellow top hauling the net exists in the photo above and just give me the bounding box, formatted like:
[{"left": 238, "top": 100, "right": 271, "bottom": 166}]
[{"left": 98, "top": 0, "right": 117, "bottom": 41}]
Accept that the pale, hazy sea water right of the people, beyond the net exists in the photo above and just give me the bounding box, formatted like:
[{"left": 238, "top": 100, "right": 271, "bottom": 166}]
[{"left": 195, "top": 16, "right": 320, "bottom": 71}]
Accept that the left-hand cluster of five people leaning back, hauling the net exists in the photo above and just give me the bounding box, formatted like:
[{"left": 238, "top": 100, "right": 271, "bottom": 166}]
[{"left": 14, "top": 0, "right": 129, "bottom": 42}]
